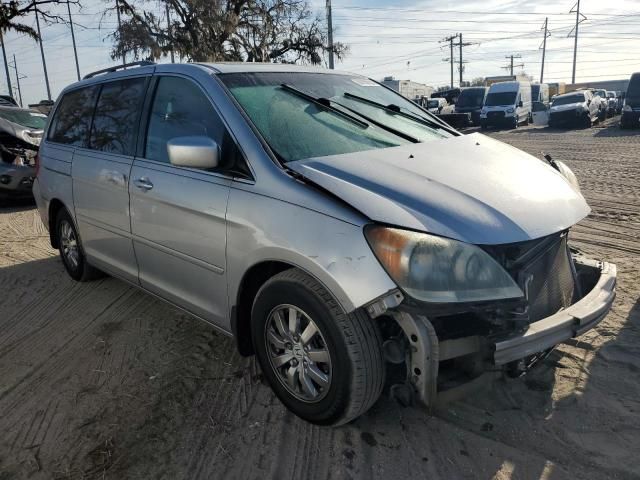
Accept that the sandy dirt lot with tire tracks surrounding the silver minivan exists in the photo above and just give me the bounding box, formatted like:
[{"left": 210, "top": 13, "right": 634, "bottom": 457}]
[{"left": 0, "top": 117, "right": 640, "bottom": 480}]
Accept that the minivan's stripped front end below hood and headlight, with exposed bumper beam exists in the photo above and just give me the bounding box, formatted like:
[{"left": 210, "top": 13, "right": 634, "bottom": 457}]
[{"left": 367, "top": 231, "right": 616, "bottom": 408}]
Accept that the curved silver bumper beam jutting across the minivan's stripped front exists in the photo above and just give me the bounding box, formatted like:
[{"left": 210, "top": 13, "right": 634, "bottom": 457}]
[{"left": 493, "top": 260, "right": 616, "bottom": 365}]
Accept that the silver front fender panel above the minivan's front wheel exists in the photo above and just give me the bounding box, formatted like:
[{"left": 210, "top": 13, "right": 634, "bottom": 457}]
[{"left": 227, "top": 183, "right": 397, "bottom": 318}]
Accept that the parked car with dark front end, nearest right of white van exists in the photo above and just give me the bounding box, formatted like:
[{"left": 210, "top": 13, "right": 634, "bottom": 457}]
[{"left": 549, "top": 90, "right": 600, "bottom": 128}]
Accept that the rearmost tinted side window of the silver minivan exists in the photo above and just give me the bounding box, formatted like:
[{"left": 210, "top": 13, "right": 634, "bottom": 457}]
[{"left": 47, "top": 86, "right": 99, "bottom": 147}]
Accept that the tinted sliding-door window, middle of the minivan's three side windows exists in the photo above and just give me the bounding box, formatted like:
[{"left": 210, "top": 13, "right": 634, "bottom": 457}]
[{"left": 89, "top": 78, "right": 146, "bottom": 155}]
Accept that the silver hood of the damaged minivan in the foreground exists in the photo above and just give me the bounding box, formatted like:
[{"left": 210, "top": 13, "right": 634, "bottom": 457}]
[{"left": 287, "top": 133, "right": 590, "bottom": 245}]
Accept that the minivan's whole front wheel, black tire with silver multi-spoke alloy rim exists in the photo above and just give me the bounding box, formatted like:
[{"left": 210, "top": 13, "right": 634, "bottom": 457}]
[{"left": 251, "top": 268, "right": 385, "bottom": 425}]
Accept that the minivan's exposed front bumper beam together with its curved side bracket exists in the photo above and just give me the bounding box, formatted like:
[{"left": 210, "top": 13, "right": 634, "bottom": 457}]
[{"left": 388, "top": 258, "right": 616, "bottom": 408}]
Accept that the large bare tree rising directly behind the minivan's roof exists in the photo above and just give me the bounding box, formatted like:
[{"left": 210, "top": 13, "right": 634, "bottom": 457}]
[{"left": 112, "top": 0, "right": 347, "bottom": 64}]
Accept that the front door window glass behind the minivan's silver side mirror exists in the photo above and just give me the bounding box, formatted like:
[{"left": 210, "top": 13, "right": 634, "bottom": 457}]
[{"left": 145, "top": 77, "right": 230, "bottom": 163}]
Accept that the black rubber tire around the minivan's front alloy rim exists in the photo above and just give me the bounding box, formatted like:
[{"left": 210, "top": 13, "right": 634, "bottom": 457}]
[{"left": 251, "top": 268, "right": 385, "bottom": 425}]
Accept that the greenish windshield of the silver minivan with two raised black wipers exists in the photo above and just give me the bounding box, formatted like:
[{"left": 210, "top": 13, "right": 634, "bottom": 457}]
[{"left": 220, "top": 72, "right": 451, "bottom": 162}]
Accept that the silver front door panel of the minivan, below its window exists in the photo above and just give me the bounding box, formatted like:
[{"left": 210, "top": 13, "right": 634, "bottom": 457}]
[{"left": 130, "top": 159, "right": 231, "bottom": 329}]
